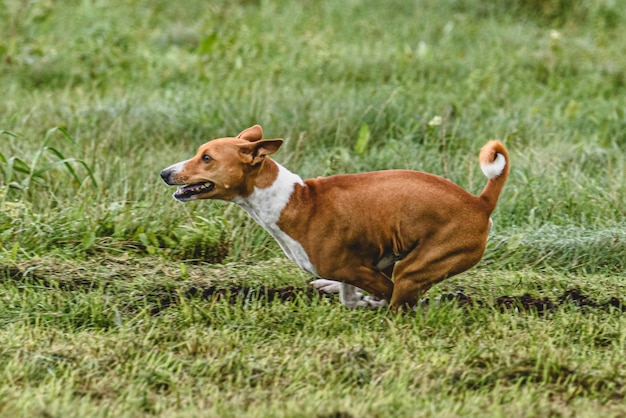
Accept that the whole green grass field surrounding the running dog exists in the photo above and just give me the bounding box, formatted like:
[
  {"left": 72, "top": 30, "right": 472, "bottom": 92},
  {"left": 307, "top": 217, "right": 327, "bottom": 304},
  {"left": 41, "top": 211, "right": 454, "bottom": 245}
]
[{"left": 0, "top": 0, "right": 626, "bottom": 418}]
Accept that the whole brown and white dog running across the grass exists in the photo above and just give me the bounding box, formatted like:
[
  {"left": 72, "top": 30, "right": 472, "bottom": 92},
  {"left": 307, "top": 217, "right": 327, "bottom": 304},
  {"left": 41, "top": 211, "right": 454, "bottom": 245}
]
[{"left": 161, "top": 125, "right": 509, "bottom": 309}]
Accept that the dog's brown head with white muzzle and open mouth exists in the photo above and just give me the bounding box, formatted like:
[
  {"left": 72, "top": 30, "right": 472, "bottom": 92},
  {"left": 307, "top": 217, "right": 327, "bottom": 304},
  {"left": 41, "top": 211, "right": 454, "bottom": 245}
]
[{"left": 161, "top": 125, "right": 283, "bottom": 202}]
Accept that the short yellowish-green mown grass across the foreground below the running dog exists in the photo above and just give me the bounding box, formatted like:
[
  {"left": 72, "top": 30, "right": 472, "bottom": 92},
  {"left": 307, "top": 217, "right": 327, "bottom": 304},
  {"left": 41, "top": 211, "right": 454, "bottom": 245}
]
[{"left": 0, "top": 260, "right": 625, "bottom": 416}]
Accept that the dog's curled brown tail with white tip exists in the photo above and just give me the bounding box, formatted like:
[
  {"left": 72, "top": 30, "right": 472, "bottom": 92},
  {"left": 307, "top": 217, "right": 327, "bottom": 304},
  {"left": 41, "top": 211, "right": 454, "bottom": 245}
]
[{"left": 478, "top": 141, "right": 509, "bottom": 214}]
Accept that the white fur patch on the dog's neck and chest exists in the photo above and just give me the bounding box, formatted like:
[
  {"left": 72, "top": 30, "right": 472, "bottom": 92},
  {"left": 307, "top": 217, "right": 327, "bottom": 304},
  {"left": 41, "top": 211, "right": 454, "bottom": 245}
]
[{"left": 233, "top": 163, "right": 317, "bottom": 275}]
